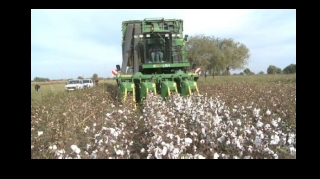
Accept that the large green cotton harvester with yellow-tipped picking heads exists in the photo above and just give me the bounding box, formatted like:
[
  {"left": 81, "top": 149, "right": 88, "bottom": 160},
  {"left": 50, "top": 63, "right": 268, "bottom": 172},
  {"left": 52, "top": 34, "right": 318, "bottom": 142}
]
[{"left": 113, "top": 18, "right": 199, "bottom": 108}]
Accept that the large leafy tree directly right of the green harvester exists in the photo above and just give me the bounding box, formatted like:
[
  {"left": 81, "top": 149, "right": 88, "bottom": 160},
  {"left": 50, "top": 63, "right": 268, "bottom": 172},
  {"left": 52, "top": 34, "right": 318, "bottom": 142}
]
[{"left": 186, "top": 35, "right": 250, "bottom": 76}]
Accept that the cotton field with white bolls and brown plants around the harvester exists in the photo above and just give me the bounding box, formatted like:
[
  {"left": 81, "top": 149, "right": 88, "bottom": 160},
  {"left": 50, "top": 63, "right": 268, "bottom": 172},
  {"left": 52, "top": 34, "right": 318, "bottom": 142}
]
[{"left": 31, "top": 74, "right": 296, "bottom": 159}]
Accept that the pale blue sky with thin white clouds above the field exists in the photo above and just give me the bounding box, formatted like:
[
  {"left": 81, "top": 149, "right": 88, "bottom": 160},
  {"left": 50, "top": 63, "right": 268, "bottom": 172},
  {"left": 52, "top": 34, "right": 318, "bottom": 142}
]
[{"left": 31, "top": 9, "right": 296, "bottom": 80}]
